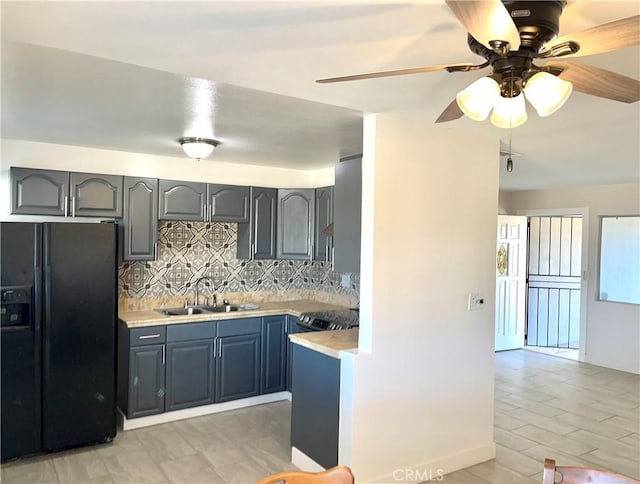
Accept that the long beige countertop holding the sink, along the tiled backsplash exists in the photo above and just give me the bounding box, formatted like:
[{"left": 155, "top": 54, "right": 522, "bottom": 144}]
[{"left": 118, "top": 300, "right": 350, "bottom": 328}]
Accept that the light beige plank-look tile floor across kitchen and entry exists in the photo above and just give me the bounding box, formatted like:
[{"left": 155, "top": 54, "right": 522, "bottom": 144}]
[{"left": 0, "top": 351, "right": 640, "bottom": 484}]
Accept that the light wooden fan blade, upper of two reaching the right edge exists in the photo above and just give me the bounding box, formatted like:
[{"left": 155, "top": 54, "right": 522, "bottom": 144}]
[{"left": 541, "top": 15, "right": 640, "bottom": 57}]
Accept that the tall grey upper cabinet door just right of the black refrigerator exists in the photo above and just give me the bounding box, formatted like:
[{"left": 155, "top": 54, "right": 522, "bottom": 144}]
[{"left": 122, "top": 176, "right": 158, "bottom": 260}]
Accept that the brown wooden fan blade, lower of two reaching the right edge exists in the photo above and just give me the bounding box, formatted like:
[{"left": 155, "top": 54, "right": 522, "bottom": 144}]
[{"left": 545, "top": 62, "right": 640, "bottom": 103}]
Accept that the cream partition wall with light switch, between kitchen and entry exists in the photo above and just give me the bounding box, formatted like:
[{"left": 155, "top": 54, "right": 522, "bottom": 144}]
[{"left": 341, "top": 115, "right": 499, "bottom": 482}]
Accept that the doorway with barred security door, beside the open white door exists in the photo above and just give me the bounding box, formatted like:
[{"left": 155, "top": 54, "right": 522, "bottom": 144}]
[{"left": 525, "top": 215, "right": 583, "bottom": 358}]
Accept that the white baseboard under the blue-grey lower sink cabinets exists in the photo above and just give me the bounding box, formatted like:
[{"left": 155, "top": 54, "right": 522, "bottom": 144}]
[{"left": 118, "top": 392, "right": 291, "bottom": 431}]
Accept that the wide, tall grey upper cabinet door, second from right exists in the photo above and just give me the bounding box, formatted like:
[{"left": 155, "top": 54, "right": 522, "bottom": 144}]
[{"left": 277, "top": 189, "right": 315, "bottom": 259}]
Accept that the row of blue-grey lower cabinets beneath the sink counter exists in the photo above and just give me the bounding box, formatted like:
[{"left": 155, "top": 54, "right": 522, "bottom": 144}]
[{"left": 118, "top": 315, "right": 296, "bottom": 418}]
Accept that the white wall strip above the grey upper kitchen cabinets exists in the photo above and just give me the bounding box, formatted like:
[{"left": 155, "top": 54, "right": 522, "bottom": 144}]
[{"left": 0, "top": 139, "right": 338, "bottom": 220}]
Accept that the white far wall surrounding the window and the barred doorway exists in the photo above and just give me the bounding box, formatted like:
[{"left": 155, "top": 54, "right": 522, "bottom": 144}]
[{"left": 508, "top": 183, "right": 640, "bottom": 373}]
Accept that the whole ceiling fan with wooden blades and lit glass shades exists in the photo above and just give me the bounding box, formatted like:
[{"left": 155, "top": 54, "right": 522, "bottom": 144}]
[{"left": 316, "top": 0, "right": 640, "bottom": 128}]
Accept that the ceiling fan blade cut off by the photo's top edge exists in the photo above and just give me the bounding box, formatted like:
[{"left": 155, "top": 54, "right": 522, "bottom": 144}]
[{"left": 446, "top": 0, "right": 520, "bottom": 50}]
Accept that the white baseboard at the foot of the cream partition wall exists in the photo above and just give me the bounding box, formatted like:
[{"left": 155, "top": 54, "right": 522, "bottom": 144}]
[{"left": 367, "top": 442, "right": 496, "bottom": 483}]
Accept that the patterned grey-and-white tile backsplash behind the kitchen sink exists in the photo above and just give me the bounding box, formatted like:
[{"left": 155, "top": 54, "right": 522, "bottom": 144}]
[{"left": 119, "top": 221, "right": 360, "bottom": 299}]
